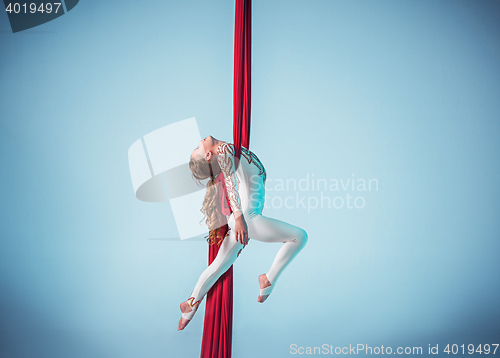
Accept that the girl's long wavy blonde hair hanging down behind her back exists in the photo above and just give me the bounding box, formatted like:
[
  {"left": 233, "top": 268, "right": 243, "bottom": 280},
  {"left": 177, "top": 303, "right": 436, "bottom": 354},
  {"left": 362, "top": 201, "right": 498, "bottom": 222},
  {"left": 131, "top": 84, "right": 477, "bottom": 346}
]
[{"left": 189, "top": 156, "right": 225, "bottom": 245}]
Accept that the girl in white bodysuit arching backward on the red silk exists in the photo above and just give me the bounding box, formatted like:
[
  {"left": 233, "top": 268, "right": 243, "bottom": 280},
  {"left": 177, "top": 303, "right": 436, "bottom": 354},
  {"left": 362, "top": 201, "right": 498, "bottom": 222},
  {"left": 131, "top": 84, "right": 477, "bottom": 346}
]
[{"left": 178, "top": 136, "right": 307, "bottom": 330}]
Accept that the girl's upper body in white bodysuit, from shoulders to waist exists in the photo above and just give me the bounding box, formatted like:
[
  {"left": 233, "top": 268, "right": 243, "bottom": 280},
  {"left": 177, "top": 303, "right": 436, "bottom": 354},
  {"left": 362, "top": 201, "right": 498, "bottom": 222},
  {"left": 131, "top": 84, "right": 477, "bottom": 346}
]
[{"left": 217, "top": 143, "right": 266, "bottom": 217}]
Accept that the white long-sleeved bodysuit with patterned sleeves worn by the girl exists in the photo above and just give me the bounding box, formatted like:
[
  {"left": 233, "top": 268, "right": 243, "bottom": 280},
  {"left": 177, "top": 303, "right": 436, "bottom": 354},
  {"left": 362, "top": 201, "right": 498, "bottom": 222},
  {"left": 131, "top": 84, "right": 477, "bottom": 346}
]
[{"left": 188, "top": 143, "right": 307, "bottom": 310}]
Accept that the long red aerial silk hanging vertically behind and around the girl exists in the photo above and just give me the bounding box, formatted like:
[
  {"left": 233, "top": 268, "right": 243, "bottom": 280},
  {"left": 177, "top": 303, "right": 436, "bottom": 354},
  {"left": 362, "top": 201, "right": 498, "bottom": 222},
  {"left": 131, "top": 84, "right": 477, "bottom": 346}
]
[{"left": 201, "top": 0, "right": 252, "bottom": 358}]
